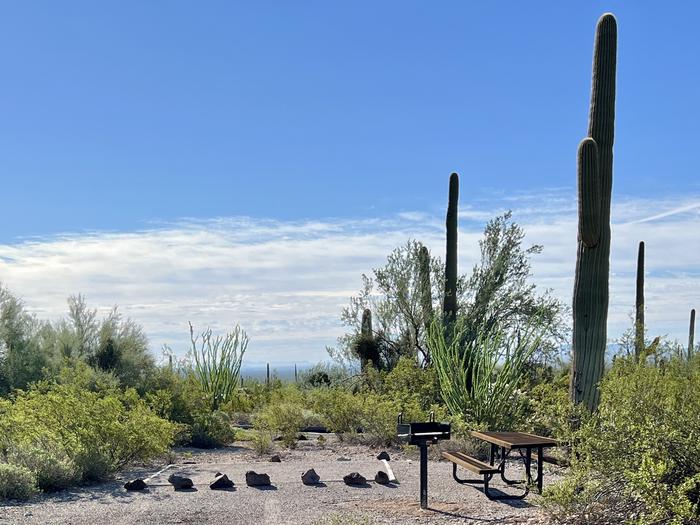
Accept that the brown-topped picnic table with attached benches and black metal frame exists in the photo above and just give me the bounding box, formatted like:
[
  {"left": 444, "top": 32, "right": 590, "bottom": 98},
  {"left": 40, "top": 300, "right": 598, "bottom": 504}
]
[{"left": 442, "top": 431, "right": 557, "bottom": 499}]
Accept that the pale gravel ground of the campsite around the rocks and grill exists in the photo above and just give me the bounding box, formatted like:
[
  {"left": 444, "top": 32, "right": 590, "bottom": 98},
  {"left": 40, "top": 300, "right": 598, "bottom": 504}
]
[{"left": 0, "top": 437, "right": 558, "bottom": 525}]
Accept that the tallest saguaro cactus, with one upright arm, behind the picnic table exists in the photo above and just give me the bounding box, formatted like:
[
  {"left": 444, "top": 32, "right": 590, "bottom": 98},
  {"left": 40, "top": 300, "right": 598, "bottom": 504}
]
[{"left": 570, "top": 13, "right": 617, "bottom": 410}]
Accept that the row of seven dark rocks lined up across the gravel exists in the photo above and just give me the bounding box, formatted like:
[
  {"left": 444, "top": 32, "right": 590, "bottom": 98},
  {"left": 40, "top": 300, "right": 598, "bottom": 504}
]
[{"left": 124, "top": 469, "right": 391, "bottom": 491}]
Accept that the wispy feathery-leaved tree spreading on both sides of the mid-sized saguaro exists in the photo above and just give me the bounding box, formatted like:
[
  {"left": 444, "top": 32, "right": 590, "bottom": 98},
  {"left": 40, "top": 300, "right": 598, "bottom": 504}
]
[{"left": 328, "top": 212, "right": 565, "bottom": 368}]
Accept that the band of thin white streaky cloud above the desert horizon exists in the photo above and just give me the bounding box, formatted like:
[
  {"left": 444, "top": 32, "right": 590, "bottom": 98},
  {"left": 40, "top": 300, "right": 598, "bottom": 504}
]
[{"left": 0, "top": 190, "right": 700, "bottom": 363}]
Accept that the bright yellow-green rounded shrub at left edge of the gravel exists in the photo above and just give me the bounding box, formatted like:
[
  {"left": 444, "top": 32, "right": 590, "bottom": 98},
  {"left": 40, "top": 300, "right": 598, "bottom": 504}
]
[{"left": 0, "top": 383, "right": 175, "bottom": 488}]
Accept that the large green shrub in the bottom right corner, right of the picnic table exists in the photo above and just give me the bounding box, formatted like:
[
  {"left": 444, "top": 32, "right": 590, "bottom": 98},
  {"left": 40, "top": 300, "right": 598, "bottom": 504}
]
[{"left": 547, "top": 358, "right": 700, "bottom": 525}]
